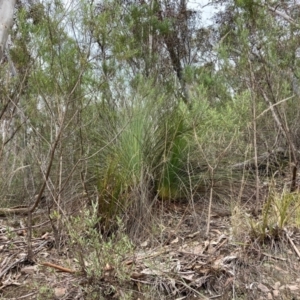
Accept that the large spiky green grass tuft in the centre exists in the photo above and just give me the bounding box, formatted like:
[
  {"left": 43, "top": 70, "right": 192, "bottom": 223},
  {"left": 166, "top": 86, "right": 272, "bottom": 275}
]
[{"left": 91, "top": 83, "right": 195, "bottom": 226}]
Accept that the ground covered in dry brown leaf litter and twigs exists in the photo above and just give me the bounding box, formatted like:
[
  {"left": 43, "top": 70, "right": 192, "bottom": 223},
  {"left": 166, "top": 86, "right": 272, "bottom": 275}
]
[{"left": 0, "top": 198, "right": 300, "bottom": 300}]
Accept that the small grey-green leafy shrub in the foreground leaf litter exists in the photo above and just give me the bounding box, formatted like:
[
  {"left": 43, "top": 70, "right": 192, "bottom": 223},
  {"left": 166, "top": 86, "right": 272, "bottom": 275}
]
[{"left": 68, "top": 204, "right": 133, "bottom": 283}]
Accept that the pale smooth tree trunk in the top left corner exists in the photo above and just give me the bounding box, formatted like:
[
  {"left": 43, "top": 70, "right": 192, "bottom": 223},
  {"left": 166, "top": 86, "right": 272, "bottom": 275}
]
[{"left": 0, "top": 0, "right": 16, "bottom": 61}]
